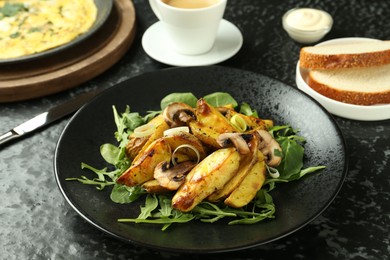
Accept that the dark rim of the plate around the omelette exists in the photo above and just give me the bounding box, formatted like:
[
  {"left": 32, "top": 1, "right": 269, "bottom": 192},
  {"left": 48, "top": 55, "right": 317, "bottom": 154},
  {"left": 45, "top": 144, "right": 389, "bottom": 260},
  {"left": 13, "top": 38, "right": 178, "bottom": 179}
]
[{"left": 0, "top": 0, "right": 113, "bottom": 65}]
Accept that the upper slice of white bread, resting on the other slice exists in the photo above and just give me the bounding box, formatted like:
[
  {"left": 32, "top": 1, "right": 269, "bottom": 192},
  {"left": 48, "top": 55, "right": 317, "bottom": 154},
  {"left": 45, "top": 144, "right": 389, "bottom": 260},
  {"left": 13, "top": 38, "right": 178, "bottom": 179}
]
[{"left": 299, "top": 41, "right": 390, "bottom": 69}]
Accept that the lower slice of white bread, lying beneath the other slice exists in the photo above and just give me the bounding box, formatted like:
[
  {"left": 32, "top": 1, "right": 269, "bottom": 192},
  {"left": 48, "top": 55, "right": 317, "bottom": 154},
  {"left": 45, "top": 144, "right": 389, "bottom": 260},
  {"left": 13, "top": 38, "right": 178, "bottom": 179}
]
[{"left": 306, "top": 64, "right": 390, "bottom": 105}]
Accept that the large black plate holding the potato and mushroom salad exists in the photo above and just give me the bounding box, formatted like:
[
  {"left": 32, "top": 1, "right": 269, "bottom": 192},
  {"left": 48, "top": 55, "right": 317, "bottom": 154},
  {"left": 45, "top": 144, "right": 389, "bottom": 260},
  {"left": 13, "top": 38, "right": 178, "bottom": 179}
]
[{"left": 55, "top": 66, "right": 347, "bottom": 253}]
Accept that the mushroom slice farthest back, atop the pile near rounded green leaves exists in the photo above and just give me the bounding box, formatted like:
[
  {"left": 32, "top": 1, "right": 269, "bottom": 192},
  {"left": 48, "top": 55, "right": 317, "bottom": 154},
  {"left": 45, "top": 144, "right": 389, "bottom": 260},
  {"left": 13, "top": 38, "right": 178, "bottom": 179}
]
[{"left": 163, "top": 102, "right": 196, "bottom": 128}]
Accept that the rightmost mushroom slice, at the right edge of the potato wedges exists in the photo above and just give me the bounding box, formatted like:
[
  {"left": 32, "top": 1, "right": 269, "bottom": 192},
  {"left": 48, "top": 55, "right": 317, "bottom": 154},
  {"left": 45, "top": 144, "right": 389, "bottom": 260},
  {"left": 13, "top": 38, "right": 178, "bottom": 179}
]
[{"left": 256, "top": 130, "right": 282, "bottom": 167}]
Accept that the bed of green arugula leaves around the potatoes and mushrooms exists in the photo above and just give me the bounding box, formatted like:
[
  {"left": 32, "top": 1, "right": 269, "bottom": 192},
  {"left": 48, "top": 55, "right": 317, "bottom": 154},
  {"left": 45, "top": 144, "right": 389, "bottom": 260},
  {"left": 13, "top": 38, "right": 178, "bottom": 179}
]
[{"left": 67, "top": 92, "right": 324, "bottom": 230}]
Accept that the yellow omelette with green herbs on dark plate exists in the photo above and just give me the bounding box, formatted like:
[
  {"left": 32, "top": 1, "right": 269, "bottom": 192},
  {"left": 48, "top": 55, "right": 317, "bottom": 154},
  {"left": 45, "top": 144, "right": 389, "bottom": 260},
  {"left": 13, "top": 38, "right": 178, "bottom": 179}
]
[{"left": 0, "top": 0, "right": 97, "bottom": 59}]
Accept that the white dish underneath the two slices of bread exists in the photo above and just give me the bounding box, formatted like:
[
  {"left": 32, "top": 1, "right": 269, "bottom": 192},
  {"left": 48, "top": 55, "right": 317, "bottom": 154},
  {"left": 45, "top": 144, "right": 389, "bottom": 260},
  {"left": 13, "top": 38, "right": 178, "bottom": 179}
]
[{"left": 296, "top": 37, "right": 390, "bottom": 121}]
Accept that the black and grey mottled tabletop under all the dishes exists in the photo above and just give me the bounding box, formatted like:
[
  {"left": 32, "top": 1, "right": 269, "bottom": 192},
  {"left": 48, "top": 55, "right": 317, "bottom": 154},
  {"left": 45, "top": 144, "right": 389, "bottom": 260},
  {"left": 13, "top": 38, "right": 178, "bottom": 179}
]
[{"left": 0, "top": 0, "right": 390, "bottom": 259}]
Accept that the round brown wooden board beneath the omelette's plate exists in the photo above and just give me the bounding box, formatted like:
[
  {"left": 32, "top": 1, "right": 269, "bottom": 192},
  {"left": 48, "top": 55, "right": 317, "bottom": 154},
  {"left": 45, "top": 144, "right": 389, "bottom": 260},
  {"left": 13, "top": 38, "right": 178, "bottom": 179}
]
[{"left": 0, "top": 0, "right": 136, "bottom": 102}]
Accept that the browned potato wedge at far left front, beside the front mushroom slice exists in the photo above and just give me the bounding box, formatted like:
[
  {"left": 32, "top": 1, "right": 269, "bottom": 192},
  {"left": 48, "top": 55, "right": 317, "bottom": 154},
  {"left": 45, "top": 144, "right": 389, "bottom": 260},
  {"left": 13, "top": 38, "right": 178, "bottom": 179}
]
[{"left": 117, "top": 138, "right": 172, "bottom": 186}]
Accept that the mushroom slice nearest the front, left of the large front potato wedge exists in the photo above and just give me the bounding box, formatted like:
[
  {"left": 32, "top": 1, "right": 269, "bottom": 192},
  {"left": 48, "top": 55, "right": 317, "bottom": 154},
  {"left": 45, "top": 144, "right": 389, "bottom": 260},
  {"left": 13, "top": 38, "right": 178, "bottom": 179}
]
[{"left": 154, "top": 161, "right": 196, "bottom": 190}]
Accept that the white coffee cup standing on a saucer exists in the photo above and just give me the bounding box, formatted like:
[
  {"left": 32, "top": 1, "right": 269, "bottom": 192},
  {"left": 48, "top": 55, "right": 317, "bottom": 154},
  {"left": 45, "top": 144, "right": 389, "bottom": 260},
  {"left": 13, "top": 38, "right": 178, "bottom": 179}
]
[{"left": 149, "top": 0, "right": 227, "bottom": 55}]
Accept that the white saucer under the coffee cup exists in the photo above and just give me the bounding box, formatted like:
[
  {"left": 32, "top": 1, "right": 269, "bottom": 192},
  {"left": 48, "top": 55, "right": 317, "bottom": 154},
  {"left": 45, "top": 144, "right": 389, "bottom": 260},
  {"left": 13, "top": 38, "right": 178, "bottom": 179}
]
[{"left": 142, "top": 20, "right": 243, "bottom": 67}]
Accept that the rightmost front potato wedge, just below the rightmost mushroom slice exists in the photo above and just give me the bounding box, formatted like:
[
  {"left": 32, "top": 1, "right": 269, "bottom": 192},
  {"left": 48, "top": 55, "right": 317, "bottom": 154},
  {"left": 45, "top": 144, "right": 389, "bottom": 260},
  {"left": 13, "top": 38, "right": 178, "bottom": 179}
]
[{"left": 224, "top": 152, "right": 266, "bottom": 208}]
